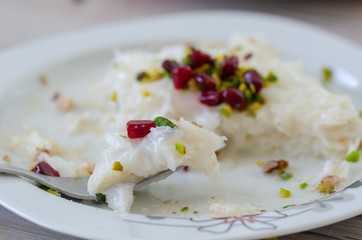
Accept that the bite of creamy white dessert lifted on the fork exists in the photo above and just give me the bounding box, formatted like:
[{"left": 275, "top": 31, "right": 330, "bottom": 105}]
[{"left": 88, "top": 118, "right": 226, "bottom": 212}]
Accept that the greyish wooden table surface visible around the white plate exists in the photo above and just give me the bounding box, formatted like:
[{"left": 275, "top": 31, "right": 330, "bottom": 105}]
[{"left": 0, "top": 0, "right": 362, "bottom": 240}]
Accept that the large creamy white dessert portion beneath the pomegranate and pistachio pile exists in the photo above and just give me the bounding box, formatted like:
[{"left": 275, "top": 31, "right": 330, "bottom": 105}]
[{"left": 106, "top": 35, "right": 361, "bottom": 160}]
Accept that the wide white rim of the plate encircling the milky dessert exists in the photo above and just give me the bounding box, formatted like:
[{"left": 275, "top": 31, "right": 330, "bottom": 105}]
[{"left": 0, "top": 11, "right": 362, "bottom": 239}]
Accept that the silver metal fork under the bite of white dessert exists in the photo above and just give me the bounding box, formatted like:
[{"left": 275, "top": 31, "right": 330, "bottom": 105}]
[{"left": 0, "top": 164, "right": 184, "bottom": 200}]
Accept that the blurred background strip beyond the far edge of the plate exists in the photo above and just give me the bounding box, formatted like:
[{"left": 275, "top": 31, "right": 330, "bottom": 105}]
[{"left": 0, "top": 0, "right": 362, "bottom": 49}]
